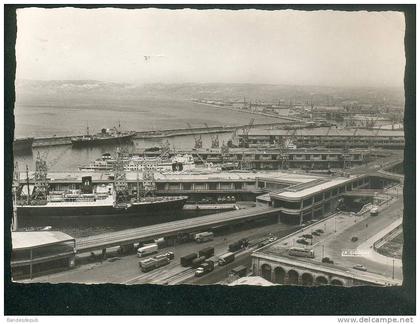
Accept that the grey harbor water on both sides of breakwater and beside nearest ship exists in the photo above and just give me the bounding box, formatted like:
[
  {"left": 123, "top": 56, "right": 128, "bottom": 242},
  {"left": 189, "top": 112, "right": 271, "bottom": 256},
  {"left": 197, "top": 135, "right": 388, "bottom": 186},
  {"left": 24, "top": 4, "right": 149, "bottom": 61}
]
[{"left": 14, "top": 100, "right": 286, "bottom": 237}]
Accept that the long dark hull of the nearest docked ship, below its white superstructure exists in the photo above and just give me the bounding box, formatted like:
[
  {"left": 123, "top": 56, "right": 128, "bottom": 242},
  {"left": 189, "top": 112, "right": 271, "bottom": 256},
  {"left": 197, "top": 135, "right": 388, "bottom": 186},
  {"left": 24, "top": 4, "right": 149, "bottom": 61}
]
[{"left": 17, "top": 197, "right": 188, "bottom": 218}]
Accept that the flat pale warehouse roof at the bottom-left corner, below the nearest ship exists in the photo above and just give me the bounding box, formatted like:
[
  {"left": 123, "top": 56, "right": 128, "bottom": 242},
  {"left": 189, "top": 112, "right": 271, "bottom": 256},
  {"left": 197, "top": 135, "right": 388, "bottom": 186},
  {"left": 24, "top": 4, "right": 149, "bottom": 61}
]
[{"left": 12, "top": 231, "right": 74, "bottom": 250}]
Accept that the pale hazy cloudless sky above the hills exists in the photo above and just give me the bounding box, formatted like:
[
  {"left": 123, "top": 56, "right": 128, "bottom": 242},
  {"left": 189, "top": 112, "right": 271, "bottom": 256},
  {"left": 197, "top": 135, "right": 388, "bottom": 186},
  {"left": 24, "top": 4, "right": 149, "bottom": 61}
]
[{"left": 16, "top": 8, "right": 405, "bottom": 87}]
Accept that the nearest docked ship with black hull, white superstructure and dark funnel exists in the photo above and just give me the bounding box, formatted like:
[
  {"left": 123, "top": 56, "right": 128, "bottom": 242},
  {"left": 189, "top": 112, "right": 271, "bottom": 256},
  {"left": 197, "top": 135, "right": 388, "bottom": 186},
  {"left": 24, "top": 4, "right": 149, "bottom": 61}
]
[{"left": 15, "top": 155, "right": 188, "bottom": 217}]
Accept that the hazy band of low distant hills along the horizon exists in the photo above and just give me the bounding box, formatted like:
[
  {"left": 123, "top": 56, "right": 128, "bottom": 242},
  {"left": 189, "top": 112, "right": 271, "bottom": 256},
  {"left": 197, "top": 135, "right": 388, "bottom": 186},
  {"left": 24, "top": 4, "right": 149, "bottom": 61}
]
[{"left": 15, "top": 80, "right": 404, "bottom": 105}]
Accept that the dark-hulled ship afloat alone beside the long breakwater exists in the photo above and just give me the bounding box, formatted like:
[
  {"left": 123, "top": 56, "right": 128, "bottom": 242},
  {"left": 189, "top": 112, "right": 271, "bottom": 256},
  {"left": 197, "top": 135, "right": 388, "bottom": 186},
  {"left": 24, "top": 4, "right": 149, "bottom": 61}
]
[{"left": 71, "top": 125, "right": 136, "bottom": 146}]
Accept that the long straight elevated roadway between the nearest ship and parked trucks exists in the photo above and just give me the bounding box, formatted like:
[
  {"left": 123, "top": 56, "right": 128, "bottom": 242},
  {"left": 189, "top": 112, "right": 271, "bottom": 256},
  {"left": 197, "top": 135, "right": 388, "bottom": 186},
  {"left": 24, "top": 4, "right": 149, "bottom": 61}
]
[{"left": 76, "top": 206, "right": 280, "bottom": 253}]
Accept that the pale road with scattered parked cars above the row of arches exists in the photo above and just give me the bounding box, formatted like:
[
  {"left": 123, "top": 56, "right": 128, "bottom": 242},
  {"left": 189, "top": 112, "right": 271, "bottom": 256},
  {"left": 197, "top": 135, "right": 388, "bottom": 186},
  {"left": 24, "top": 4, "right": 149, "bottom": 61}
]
[{"left": 261, "top": 188, "right": 403, "bottom": 281}]
